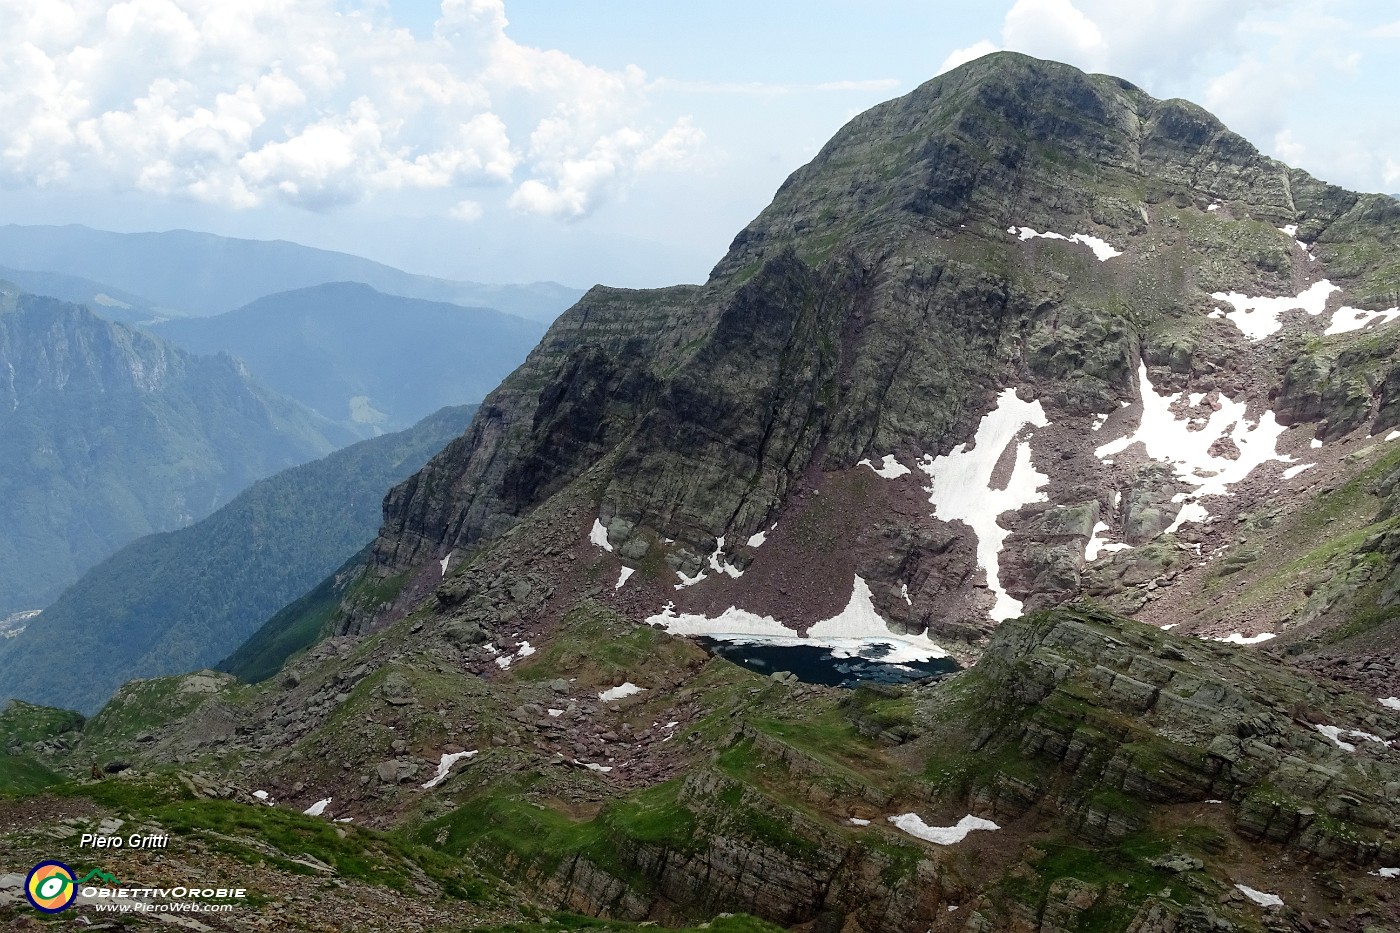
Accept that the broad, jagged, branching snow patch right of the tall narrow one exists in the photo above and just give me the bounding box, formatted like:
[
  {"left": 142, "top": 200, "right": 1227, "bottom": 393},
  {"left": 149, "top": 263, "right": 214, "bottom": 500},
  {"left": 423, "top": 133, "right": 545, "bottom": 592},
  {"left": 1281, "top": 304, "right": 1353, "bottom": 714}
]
[{"left": 1093, "top": 361, "right": 1294, "bottom": 532}]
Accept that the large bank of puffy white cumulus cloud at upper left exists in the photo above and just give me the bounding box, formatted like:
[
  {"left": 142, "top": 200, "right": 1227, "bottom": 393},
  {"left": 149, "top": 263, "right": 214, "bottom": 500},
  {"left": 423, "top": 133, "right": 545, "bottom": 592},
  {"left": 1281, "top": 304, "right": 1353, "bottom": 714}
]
[{"left": 0, "top": 0, "right": 703, "bottom": 217}]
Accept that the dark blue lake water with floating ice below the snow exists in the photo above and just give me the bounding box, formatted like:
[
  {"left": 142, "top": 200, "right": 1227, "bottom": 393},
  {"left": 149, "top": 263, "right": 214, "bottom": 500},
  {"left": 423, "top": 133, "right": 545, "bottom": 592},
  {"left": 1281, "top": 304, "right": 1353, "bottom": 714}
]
[{"left": 696, "top": 636, "right": 959, "bottom": 688}]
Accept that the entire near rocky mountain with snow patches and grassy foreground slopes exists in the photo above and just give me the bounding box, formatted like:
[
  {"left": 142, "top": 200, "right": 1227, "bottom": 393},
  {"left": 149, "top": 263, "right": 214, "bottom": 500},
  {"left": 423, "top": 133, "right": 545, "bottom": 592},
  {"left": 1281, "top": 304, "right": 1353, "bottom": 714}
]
[{"left": 0, "top": 53, "right": 1400, "bottom": 933}]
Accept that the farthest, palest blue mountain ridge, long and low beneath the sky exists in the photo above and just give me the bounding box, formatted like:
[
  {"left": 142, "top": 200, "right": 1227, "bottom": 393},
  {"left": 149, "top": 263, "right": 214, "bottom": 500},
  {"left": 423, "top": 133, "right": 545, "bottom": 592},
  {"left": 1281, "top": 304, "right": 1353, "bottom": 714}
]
[{"left": 0, "top": 224, "right": 582, "bottom": 324}]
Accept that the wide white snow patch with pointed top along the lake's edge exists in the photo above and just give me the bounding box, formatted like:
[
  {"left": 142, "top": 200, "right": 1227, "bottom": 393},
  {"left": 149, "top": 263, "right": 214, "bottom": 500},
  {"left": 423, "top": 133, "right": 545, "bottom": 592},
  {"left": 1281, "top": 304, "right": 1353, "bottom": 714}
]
[{"left": 647, "top": 576, "right": 948, "bottom": 664}]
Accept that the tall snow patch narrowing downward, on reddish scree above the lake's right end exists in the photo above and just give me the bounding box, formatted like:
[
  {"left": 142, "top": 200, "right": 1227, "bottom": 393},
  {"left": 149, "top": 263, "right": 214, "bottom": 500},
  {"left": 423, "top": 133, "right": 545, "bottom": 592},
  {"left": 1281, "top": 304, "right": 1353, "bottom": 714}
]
[{"left": 918, "top": 388, "right": 1050, "bottom": 622}]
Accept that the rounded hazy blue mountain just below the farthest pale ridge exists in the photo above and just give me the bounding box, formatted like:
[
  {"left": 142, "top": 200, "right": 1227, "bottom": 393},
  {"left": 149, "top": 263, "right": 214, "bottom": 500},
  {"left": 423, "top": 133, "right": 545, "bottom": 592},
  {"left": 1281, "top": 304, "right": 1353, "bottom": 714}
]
[{"left": 153, "top": 282, "right": 545, "bottom": 433}]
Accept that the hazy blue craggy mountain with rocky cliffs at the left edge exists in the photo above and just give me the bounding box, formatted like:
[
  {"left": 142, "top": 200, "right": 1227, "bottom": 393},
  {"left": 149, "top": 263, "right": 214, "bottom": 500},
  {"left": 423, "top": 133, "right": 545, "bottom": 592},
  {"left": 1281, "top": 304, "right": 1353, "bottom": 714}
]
[{"left": 0, "top": 287, "right": 351, "bottom": 614}]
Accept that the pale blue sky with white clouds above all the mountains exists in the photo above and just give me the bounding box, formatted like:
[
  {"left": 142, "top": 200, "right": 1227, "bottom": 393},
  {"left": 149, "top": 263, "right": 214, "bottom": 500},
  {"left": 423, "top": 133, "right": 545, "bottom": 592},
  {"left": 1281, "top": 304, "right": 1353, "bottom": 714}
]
[{"left": 0, "top": 0, "right": 1400, "bottom": 287}]
